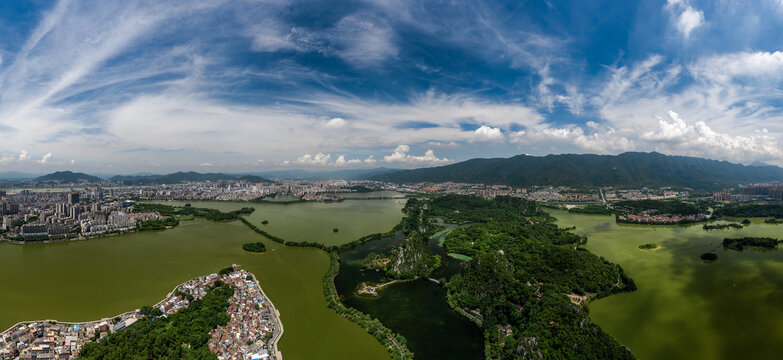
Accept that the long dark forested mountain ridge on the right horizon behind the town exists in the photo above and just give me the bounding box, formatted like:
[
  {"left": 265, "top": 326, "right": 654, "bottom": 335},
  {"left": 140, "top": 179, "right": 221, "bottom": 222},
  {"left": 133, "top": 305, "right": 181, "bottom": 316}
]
[{"left": 370, "top": 152, "right": 783, "bottom": 190}]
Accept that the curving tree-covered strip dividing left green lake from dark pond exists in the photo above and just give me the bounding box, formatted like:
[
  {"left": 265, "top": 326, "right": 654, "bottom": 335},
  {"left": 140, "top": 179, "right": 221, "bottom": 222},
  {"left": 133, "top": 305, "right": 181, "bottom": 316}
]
[{"left": 324, "top": 252, "right": 413, "bottom": 360}]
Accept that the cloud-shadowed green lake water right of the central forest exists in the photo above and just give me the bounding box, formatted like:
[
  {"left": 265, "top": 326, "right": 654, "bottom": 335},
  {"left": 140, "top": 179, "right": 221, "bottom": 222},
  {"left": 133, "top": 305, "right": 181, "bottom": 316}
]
[{"left": 552, "top": 211, "right": 783, "bottom": 359}]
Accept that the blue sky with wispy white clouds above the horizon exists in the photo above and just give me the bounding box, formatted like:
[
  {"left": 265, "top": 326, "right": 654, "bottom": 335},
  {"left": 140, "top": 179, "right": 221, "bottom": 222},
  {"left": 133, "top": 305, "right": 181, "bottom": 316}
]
[{"left": 0, "top": 0, "right": 783, "bottom": 174}]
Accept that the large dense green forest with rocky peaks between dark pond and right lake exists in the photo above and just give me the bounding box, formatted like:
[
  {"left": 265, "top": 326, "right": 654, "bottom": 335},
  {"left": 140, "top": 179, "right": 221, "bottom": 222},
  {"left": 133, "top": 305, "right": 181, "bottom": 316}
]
[{"left": 426, "top": 195, "right": 636, "bottom": 359}]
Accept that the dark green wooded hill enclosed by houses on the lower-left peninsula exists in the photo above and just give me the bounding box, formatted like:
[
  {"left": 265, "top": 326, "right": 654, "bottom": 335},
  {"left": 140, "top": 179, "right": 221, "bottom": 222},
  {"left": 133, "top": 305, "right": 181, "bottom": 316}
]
[{"left": 79, "top": 283, "right": 234, "bottom": 359}]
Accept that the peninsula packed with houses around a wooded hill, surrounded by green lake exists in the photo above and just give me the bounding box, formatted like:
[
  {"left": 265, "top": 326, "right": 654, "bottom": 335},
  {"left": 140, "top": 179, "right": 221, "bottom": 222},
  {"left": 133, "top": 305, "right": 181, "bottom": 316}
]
[{"left": 0, "top": 265, "right": 283, "bottom": 360}]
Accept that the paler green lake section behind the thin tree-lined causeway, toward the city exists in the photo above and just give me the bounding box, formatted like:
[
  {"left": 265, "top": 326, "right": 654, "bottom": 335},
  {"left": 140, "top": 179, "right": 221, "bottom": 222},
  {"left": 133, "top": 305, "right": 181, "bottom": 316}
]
[{"left": 160, "top": 198, "right": 406, "bottom": 245}]
